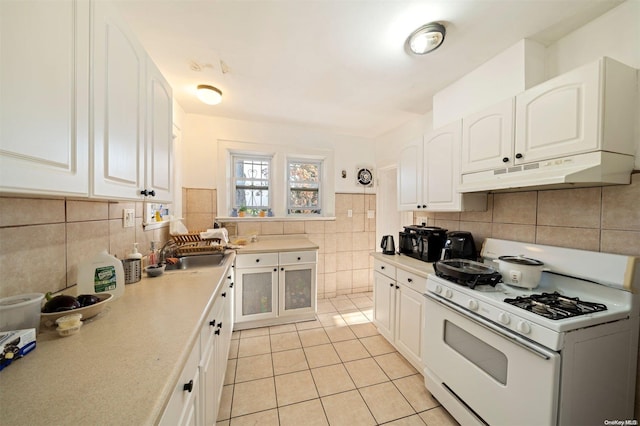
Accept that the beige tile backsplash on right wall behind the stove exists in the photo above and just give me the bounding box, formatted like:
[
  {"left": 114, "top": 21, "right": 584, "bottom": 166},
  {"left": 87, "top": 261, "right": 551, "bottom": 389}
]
[{"left": 414, "top": 173, "right": 640, "bottom": 256}]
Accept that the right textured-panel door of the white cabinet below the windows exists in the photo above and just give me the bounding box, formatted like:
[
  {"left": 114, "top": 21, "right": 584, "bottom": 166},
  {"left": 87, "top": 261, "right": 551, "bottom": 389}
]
[{"left": 279, "top": 264, "right": 316, "bottom": 315}]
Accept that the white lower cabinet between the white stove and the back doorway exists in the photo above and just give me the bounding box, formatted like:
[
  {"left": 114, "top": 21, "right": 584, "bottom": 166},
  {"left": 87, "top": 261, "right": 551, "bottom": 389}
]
[{"left": 373, "top": 260, "right": 426, "bottom": 371}]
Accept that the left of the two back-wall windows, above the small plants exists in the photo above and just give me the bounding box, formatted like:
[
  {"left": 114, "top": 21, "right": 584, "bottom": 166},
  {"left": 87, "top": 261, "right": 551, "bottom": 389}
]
[{"left": 232, "top": 156, "right": 271, "bottom": 214}]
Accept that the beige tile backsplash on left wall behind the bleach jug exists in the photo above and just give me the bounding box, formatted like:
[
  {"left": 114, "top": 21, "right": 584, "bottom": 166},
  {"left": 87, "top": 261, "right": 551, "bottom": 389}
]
[{"left": 0, "top": 196, "right": 169, "bottom": 297}]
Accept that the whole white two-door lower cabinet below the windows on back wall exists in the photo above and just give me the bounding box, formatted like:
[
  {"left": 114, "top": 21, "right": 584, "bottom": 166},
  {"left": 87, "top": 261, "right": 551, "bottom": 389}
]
[{"left": 235, "top": 250, "right": 317, "bottom": 329}]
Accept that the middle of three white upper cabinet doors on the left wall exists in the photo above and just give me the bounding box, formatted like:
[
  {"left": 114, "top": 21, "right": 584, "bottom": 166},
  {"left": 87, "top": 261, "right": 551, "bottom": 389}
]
[{"left": 92, "top": 1, "right": 146, "bottom": 199}]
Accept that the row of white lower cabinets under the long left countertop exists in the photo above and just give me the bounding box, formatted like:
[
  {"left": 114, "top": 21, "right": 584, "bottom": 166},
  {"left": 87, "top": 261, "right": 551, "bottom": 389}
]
[{"left": 160, "top": 267, "right": 234, "bottom": 426}]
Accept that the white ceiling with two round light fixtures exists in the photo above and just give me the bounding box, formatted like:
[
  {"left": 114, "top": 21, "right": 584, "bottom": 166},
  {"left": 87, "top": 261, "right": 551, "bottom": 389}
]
[{"left": 112, "top": 0, "right": 622, "bottom": 137}]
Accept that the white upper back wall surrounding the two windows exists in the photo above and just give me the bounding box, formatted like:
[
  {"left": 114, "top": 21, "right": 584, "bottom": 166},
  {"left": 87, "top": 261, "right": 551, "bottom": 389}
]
[{"left": 182, "top": 114, "right": 375, "bottom": 193}]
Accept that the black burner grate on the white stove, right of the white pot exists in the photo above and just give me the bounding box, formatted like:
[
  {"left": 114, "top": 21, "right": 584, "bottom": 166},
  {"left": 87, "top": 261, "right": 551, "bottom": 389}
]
[{"left": 504, "top": 291, "right": 607, "bottom": 320}]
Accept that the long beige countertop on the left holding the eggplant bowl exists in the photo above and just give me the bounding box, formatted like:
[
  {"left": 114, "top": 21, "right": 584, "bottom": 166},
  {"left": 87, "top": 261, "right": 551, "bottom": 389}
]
[{"left": 0, "top": 252, "right": 235, "bottom": 426}]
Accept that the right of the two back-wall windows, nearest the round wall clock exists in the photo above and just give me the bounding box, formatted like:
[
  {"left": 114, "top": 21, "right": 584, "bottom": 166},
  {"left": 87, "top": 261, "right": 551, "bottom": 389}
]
[{"left": 287, "top": 159, "right": 322, "bottom": 215}]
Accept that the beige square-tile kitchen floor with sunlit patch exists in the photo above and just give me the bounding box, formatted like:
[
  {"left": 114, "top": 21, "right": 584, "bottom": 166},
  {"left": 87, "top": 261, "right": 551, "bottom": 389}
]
[{"left": 218, "top": 293, "right": 457, "bottom": 426}]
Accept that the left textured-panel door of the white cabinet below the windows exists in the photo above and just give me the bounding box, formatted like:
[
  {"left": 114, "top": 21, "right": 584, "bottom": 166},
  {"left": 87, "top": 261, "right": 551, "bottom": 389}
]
[{"left": 236, "top": 266, "right": 278, "bottom": 321}]
